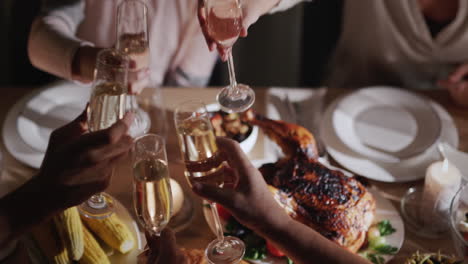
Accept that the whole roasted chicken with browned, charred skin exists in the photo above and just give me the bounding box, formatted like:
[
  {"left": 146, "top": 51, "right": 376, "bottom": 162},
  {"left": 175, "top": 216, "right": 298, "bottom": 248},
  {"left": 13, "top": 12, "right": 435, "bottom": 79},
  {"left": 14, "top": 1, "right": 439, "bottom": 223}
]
[{"left": 243, "top": 110, "right": 375, "bottom": 252}]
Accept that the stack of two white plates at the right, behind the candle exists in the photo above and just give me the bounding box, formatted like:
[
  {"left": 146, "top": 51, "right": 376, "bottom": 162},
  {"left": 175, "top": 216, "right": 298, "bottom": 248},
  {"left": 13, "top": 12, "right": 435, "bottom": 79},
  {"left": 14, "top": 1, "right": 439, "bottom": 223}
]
[{"left": 321, "top": 87, "right": 458, "bottom": 182}]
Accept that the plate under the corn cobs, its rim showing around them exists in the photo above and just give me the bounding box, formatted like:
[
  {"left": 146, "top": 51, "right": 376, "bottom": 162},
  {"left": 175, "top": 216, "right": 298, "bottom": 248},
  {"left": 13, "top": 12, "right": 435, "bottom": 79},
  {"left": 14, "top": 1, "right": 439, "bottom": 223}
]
[{"left": 23, "top": 200, "right": 145, "bottom": 264}]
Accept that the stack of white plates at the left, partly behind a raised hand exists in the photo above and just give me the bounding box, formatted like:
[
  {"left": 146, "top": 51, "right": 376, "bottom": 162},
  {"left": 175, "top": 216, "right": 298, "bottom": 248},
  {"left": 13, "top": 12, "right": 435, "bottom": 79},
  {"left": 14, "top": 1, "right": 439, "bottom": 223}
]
[{"left": 3, "top": 82, "right": 91, "bottom": 168}]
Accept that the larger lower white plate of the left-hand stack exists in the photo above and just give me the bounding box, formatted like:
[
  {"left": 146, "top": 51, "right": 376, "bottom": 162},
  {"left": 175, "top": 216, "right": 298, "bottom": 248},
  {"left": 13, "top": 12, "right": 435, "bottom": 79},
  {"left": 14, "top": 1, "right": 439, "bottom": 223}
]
[{"left": 2, "top": 82, "right": 89, "bottom": 169}]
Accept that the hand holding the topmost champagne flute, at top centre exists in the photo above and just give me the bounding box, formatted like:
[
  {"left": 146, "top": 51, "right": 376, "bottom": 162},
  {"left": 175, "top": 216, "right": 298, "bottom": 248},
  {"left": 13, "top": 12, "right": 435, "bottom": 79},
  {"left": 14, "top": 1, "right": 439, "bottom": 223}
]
[{"left": 198, "top": 0, "right": 280, "bottom": 61}]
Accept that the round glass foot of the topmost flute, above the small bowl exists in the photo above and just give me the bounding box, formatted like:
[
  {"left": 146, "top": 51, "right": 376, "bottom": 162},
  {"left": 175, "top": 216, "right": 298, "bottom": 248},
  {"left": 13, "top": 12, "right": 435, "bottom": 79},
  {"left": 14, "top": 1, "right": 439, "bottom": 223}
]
[{"left": 216, "top": 84, "right": 255, "bottom": 113}]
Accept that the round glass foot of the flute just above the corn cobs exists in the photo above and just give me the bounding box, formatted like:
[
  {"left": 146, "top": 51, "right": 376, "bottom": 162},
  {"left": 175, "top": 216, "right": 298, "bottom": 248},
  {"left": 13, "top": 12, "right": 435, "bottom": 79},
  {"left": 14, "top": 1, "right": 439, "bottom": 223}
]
[{"left": 78, "top": 193, "right": 115, "bottom": 219}]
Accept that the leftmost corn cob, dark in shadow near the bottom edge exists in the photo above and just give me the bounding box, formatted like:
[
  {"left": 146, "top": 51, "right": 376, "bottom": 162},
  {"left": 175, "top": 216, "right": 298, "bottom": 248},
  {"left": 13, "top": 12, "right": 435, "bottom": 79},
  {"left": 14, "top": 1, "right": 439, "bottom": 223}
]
[{"left": 31, "top": 221, "right": 71, "bottom": 264}]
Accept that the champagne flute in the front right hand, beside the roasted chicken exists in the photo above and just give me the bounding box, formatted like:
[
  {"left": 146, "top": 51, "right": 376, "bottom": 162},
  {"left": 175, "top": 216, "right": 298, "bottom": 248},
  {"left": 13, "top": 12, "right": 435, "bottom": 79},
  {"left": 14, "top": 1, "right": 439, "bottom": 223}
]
[{"left": 174, "top": 101, "right": 245, "bottom": 264}]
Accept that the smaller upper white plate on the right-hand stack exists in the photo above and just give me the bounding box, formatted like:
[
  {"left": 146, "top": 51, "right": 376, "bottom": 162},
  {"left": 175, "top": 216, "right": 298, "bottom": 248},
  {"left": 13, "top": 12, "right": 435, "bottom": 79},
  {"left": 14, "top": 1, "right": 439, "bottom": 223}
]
[{"left": 332, "top": 86, "right": 441, "bottom": 163}]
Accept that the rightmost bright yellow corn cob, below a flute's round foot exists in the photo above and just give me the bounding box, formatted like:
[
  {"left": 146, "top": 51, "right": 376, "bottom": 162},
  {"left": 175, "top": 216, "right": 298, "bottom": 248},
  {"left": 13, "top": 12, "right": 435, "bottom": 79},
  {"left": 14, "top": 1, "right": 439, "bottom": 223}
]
[{"left": 82, "top": 214, "right": 135, "bottom": 254}]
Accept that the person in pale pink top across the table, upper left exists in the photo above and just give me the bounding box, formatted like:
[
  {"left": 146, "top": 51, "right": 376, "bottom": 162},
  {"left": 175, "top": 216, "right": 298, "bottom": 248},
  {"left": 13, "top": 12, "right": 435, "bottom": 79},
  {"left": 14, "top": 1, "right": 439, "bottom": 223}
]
[{"left": 28, "top": 0, "right": 217, "bottom": 93}]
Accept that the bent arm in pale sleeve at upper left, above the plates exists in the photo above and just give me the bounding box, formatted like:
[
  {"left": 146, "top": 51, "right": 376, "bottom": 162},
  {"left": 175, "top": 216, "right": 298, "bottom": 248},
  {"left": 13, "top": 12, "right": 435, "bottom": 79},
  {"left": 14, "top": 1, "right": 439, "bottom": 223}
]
[{"left": 28, "top": 0, "right": 99, "bottom": 82}]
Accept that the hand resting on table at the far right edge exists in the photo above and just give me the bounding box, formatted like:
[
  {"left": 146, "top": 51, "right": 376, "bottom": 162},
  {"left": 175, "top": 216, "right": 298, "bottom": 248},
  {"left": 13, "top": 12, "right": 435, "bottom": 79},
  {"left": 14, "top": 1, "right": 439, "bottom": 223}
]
[{"left": 438, "top": 63, "right": 468, "bottom": 107}]
